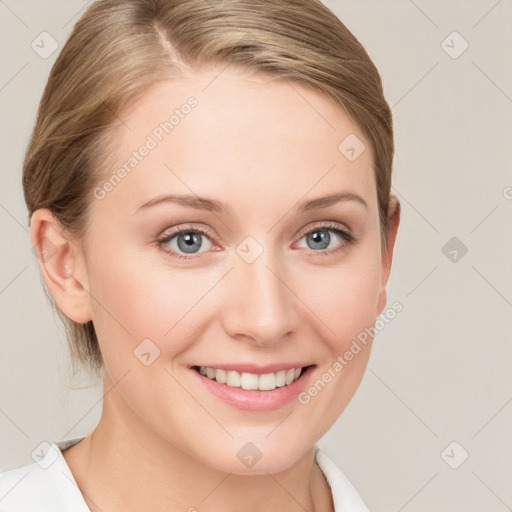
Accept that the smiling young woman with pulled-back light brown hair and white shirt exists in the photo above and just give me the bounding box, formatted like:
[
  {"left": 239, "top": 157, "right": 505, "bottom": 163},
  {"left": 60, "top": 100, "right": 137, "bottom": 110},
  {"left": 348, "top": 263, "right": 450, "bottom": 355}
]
[{"left": 0, "top": 0, "right": 400, "bottom": 512}]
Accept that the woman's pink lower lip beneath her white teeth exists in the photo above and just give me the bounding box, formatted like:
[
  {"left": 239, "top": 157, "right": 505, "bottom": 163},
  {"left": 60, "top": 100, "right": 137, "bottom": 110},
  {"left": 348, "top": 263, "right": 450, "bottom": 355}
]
[{"left": 191, "top": 365, "right": 314, "bottom": 411}]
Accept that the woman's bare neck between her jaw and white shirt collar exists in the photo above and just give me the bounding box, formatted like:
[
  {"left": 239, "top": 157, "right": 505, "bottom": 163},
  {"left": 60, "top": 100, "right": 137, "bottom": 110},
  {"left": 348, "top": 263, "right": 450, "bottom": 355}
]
[{"left": 63, "top": 372, "right": 334, "bottom": 512}]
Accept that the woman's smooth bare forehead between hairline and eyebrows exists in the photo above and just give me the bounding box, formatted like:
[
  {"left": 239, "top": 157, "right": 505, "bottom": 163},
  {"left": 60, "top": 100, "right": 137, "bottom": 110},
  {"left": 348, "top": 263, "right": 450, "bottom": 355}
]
[{"left": 93, "top": 65, "right": 376, "bottom": 211}]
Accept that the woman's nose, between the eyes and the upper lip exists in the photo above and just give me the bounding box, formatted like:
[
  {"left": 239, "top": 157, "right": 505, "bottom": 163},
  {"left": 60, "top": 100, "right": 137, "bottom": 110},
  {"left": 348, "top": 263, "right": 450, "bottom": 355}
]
[{"left": 221, "top": 244, "right": 299, "bottom": 346}]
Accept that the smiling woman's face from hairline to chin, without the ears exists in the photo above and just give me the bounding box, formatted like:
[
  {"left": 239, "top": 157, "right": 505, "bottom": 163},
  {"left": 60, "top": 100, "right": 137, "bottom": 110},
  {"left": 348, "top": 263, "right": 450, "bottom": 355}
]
[{"left": 75, "top": 66, "right": 396, "bottom": 474}]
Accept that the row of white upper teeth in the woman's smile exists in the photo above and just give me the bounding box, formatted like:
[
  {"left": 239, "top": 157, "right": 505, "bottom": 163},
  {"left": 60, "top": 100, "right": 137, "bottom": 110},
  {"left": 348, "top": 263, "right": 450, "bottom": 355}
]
[{"left": 199, "top": 366, "right": 302, "bottom": 391}]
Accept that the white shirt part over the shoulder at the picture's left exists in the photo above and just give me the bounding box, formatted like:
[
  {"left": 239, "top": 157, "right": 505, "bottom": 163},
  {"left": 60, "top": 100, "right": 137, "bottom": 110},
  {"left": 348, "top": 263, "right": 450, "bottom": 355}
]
[{"left": 0, "top": 439, "right": 90, "bottom": 512}]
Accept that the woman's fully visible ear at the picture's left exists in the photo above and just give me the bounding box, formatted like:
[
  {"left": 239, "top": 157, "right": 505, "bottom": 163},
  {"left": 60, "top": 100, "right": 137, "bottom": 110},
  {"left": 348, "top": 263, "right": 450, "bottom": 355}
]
[{"left": 30, "top": 208, "right": 92, "bottom": 324}]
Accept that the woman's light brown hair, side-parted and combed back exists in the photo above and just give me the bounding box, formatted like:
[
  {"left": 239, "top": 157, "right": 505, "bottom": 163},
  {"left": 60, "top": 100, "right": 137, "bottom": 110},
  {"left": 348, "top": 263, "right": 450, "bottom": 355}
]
[{"left": 23, "top": 0, "right": 394, "bottom": 375}]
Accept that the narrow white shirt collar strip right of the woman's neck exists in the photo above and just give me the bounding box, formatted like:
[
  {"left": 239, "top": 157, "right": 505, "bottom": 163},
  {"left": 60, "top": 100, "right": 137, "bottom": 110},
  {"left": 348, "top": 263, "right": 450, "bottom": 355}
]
[{"left": 315, "top": 445, "right": 369, "bottom": 512}]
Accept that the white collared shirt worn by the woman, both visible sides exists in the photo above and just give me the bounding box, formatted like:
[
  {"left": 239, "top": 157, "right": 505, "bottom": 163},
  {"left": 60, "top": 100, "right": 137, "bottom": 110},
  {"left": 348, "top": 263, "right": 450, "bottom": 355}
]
[{"left": 0, "top": 437, "right": 369, "bottom": 512}]
